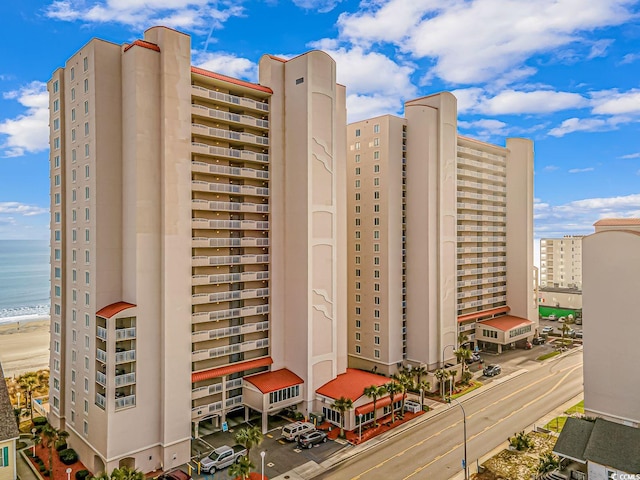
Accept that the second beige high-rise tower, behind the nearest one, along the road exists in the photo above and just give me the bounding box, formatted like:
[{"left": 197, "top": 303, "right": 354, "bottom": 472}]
[{"left": 347, "top": 93, "right": 537, "bottom": 374}]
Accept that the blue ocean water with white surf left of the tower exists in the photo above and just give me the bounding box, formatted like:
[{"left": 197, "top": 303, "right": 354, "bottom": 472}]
[{"left": 0, "top": 240, "right": 51, "bottom": 324}]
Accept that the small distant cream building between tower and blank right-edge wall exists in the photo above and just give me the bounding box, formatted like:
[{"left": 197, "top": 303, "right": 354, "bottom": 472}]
[{"left": 540, "top": 235, "right": 582, "bottom": 290}]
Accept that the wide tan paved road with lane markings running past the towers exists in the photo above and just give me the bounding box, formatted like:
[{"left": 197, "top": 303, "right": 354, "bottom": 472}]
[{"left": 315, "top": 350, "right": 582, "bottom": 480}]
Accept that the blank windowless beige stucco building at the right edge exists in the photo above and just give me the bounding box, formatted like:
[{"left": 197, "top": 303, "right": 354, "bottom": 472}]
[{"left": 582, "top": 219, "right": 640, "bottom": 427}]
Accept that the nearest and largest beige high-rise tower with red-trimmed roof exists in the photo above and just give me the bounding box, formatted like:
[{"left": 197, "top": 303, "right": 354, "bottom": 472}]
[{"left": 48, "top": 27, "right": 346, "bottom": 473}]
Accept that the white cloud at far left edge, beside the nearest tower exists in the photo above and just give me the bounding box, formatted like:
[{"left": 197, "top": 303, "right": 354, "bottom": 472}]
[{"left": 0, "top": 82, "right": 49, "bottom": 157}]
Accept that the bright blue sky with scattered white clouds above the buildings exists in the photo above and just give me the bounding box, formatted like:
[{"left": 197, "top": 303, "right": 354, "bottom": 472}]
[{"left": 0, "top": 0, "right": 640, "bottom": 262}]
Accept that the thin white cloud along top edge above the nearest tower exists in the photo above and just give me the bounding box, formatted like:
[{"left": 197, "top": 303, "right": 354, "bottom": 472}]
[{"left": 45, "top": 0, "right": 243, "bottom": 31}]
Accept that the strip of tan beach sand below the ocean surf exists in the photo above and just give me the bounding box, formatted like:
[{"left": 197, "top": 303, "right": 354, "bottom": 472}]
[{"left": 0, "top": 317, "right": 50, "bottom": 377}]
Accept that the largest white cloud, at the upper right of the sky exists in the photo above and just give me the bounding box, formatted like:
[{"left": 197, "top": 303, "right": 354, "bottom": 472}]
[{"left": 338, "top": 0, "right": 635, "bottom": 84}]
